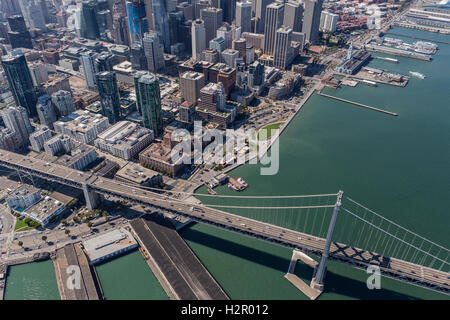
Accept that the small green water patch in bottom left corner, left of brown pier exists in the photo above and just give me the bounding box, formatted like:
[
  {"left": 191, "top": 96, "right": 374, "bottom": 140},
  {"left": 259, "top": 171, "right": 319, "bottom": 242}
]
[{"left": 5, "top": 260, "right": 60, "bottom": 300}]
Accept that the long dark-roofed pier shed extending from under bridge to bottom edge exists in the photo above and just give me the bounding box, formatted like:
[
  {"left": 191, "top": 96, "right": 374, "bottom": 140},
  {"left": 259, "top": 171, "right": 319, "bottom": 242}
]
[{"left": 131, "top": 214, "right": 229, "bottom": 300}]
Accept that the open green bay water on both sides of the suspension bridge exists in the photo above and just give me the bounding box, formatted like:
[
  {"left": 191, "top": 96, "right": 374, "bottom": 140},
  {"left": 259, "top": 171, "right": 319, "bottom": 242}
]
[{"left": 182, "top": 28, "right": 450, "bottom": 299}]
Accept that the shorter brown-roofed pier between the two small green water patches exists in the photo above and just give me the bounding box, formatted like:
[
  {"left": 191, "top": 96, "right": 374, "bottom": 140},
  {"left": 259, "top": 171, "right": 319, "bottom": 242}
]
[{"left": 53, "top": 243, "right": 103, "bottom": 300}]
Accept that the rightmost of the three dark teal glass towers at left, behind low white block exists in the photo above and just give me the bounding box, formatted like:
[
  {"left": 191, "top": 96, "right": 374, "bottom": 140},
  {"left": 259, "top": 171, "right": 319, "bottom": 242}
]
[{"left": 134, "top": 71, "right": 163, "bottom": 137}]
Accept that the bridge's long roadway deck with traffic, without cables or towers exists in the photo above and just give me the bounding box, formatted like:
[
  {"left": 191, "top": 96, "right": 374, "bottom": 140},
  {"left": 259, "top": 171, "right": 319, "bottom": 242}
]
[{"left": 0, "top": 151, "right": 450, "bottom": 294}]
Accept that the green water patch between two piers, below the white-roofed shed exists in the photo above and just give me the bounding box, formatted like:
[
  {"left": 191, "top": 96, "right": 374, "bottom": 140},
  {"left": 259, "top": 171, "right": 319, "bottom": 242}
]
[{"left": 95, "top": 250, "right": 168, "bottom": 300}]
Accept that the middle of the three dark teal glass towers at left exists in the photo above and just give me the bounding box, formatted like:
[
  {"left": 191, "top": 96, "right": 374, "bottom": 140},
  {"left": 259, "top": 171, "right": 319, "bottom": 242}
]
[{"left": 96, "top": 71, "right": 120, "bottom": 124}]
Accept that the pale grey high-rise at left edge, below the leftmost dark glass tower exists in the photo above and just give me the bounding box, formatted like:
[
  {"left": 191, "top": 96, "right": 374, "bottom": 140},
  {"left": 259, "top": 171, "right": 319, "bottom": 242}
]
[{"left": 1, "top": 107, "right": 33, "bottom": 146}]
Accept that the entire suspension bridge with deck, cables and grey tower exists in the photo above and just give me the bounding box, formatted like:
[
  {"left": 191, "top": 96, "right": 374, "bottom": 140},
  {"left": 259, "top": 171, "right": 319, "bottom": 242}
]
[{"left": 0, "top": 150, "right": 450, "bottom": 295}]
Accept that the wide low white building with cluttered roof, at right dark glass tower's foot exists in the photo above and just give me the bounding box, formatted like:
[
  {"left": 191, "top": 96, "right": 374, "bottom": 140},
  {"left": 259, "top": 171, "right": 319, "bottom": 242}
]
[{"left": 94, "top": 121, "right": 153, "bottom": 160}]
